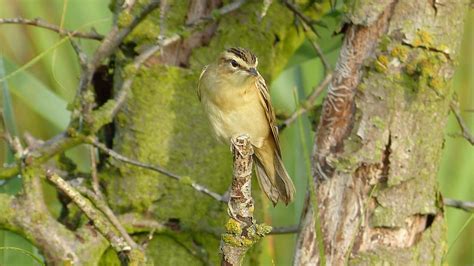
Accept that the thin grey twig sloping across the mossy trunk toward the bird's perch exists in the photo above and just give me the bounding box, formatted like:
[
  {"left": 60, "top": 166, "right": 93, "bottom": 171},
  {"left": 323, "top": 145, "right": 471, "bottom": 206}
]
[{"left": 87, "top": 138, "right": 224, "bottom": 202}]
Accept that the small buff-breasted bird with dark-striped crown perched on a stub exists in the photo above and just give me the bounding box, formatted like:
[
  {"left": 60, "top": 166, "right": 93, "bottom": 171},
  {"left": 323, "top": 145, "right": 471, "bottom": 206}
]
[{"left": 198, "top": 48, "right": 295, "bottom": 205}]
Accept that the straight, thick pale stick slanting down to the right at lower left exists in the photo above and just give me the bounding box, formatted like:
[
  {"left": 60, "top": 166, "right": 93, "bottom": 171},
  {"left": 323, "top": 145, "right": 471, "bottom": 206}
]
[{"left": 46, "top": 170, "right": 132, "bottom": 252}]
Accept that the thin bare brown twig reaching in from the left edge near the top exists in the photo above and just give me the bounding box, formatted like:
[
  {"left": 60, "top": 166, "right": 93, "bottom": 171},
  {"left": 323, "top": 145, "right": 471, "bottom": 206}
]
[{"left": 0, "top": 18, "right": 104, "bottom": 41}]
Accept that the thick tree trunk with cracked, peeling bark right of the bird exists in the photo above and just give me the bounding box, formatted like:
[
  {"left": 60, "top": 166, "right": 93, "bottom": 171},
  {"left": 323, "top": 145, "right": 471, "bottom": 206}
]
[{"left": 295, "top": 0, "right": 468, "bottom": 265}]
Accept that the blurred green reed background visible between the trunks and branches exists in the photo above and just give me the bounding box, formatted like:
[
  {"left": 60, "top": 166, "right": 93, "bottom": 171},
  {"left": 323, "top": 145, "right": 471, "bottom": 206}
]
[{"left": 0, "top": 0, "right": 474, "bottom": 265}]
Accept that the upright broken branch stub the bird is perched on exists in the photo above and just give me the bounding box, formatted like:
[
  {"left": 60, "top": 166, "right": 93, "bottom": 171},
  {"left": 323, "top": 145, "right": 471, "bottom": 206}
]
[{"left": 221, "top": 135, "right": 272, "bottom": 265}]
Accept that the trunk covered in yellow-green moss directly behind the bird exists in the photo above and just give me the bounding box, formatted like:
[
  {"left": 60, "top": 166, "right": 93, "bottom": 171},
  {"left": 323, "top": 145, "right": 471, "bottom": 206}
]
[{"left": 100, "top": 1, "right": 304, "bottom": 265}]
